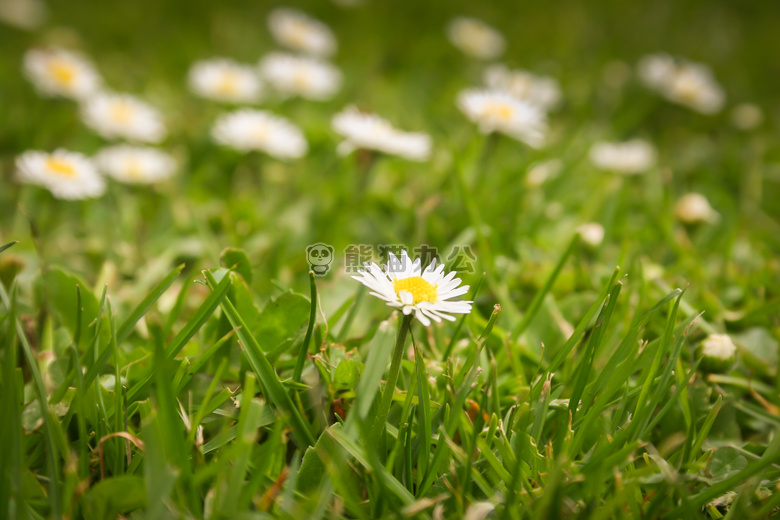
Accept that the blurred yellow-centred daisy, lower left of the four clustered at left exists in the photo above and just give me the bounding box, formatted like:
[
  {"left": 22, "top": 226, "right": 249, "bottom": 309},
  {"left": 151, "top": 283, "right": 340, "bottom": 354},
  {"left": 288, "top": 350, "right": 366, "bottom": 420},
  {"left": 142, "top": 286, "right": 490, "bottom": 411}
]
[{"left": 16, "top": 149, "right": 106, "bottom": 199}]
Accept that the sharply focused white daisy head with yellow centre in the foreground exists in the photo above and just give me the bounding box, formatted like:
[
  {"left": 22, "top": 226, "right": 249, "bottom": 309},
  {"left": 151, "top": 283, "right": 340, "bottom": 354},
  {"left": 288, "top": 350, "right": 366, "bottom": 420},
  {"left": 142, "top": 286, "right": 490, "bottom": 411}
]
[{"left": 352, "top": 251, "right": 472, "bottom": 327}]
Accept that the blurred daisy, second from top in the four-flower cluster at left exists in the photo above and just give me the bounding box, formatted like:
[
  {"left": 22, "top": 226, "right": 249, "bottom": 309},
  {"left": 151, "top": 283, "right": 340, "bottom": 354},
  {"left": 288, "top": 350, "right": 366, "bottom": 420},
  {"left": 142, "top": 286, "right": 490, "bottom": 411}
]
[{"left": 81, "top": 93, "right": 167, "bottom": 143}]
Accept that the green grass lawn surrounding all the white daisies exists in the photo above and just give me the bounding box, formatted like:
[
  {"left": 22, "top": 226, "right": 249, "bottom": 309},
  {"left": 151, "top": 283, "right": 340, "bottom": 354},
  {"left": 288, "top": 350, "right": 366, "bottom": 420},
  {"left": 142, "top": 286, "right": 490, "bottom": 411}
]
[{"left": 0, "top": 0, "right": 780, "bottom": 520}]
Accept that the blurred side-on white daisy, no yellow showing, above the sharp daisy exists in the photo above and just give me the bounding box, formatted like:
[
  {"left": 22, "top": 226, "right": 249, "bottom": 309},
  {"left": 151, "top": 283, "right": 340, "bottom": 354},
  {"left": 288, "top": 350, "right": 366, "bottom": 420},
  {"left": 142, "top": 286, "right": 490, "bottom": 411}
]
[{"left": 332, "top": 107, "right": 431, "bottom": 161}]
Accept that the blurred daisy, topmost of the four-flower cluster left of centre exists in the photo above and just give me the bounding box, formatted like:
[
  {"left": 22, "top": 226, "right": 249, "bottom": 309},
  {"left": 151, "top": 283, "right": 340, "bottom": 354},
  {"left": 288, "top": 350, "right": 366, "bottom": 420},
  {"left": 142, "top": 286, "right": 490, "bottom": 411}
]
[{"left": 268, "top": 7, "right": 336, "bottom": 56}]
